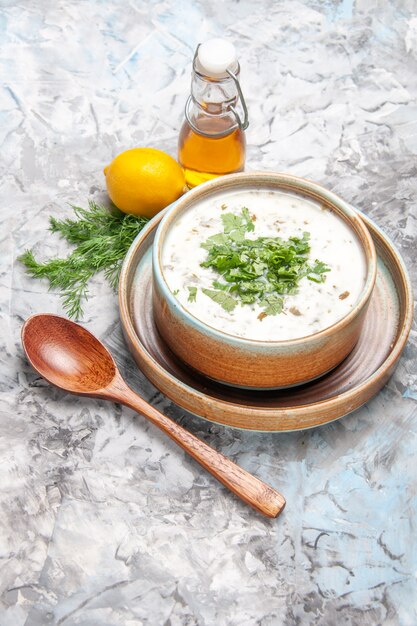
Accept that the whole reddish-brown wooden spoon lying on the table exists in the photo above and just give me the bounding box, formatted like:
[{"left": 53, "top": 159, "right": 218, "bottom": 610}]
[{"left": 22, "top": 314, "right": 285, "bottom": 517}]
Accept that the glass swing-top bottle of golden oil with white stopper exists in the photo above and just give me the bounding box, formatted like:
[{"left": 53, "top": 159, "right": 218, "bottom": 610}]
[{"left": 178, "top": 39, "right": 248, "bottom": 188}]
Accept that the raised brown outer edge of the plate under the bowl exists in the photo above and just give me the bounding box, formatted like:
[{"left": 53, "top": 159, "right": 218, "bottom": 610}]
[{"left": 119, "top": 211, "right": 413, "bottom": 432}]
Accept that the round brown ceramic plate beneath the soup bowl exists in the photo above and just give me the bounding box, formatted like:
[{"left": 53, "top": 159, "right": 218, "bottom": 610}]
[{"left": 119, "top": 213, "right": 413, "bottom": 432}]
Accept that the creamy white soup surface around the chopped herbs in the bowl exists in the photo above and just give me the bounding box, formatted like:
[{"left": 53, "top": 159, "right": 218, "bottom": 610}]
[{"left": 162, "top": 190, "right": 367, "bottom": 341}]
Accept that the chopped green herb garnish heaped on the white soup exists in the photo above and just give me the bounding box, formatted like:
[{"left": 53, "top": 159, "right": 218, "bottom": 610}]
[{"left": 197, "top": 208, "right": 330, "bottom": 315}]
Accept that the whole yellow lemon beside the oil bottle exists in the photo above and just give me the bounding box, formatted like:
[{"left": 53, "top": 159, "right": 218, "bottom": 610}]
[{"left": 104, "top": 148, "right": 186, "bottom": 217}]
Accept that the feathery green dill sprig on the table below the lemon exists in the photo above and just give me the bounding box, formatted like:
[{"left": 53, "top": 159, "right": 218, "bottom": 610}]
[{"left": 19, "top": 201, "right": 149, "bottom": 319}]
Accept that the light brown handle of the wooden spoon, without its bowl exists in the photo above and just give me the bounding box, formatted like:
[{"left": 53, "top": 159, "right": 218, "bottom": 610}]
[{"left": 113, "top": 381, "right": 285, "bottom": 517}]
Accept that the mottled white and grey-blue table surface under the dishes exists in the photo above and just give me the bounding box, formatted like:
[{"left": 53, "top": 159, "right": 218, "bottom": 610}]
[{"left": 0, "top": 0, "right": 417, "bottom": 626}]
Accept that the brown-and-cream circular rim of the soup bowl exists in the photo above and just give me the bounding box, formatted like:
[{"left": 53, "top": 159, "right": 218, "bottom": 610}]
[{"left": 152, "top": 171, "right": 377, "bottom": 349}]
